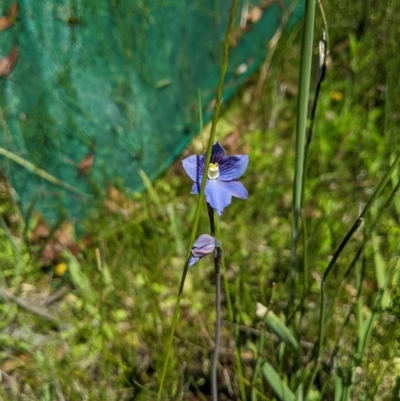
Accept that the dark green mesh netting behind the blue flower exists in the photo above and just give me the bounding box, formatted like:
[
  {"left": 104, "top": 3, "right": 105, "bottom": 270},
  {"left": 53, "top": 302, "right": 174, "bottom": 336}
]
[{"left": 0, "top": 0, "right": 303, "bottom": 221}]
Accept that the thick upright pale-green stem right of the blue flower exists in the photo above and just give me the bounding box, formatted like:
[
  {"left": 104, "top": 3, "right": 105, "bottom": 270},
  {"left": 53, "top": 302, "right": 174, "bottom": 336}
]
[{"left": 289, "top": 0, "right": 315, "bottom": 308}]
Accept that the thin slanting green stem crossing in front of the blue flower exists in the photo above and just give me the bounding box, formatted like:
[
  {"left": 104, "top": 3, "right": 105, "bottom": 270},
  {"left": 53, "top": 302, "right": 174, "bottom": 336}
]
[{"left": 157, "top": 0, "right": 238, "bottom": 401}]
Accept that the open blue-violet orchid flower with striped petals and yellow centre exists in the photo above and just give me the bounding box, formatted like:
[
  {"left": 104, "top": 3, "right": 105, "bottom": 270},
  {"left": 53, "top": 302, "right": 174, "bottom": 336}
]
[{"left": 182, "top": 142, "right": 249, "bottom": 215}]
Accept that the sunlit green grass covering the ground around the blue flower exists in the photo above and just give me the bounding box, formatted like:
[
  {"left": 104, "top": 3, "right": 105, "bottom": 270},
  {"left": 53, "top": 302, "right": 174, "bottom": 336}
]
[{"left": 0, "top": 1, "right": 400, "bottom": 401}]
